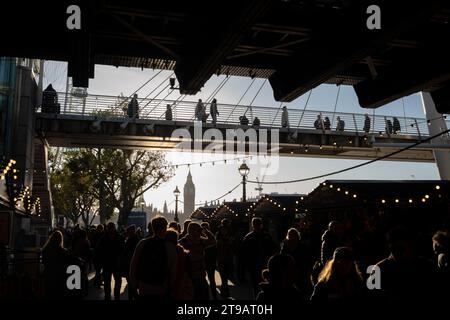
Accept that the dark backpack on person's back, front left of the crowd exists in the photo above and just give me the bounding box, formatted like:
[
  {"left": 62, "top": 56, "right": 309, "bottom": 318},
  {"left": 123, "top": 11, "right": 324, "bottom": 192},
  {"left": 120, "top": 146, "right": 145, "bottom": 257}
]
[{"left": 138, "top": 237, "right": 169, "bottom": 285}]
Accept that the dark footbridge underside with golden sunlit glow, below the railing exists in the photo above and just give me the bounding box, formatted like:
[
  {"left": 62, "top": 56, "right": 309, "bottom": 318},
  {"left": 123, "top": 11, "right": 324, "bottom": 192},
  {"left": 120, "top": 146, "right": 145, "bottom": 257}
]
[{"left": 36, "top": 114, "right": 434, "bottom": 162}]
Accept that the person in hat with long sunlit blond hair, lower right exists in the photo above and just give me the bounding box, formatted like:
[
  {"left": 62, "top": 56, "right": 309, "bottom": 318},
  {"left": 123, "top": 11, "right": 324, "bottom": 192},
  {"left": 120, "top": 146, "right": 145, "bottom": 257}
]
[{"left": 311, "top": 247, "right": 364, "bottom": 303}]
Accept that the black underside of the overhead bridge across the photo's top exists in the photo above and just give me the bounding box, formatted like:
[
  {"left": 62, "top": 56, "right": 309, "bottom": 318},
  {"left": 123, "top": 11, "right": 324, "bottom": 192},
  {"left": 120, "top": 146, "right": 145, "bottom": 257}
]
[{"left": 0, "top": 0, "right": 450, "bottom": 113}]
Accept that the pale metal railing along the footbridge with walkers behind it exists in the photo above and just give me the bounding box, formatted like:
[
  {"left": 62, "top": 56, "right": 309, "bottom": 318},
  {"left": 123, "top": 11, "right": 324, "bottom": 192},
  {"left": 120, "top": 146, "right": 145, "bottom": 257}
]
[{"left": 36, "top": 93, "right": 450, "bottom": 136}]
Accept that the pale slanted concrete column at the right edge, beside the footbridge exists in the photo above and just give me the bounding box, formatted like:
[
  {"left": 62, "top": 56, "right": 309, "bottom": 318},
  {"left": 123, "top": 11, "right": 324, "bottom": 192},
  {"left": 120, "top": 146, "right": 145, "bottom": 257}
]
[{"left": 420, "top": 92, "right": 450, "bottom": 180}]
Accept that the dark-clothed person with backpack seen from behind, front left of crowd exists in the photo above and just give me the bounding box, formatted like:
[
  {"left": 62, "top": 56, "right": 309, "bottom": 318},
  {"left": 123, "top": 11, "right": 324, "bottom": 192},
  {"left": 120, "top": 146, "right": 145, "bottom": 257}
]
[{"left": 130, "top": 217, "right": 177, "bottom": 300}]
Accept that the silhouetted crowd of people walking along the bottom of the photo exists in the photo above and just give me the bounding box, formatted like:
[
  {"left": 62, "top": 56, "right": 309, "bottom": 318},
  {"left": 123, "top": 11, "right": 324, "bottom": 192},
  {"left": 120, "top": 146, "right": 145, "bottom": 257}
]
[{"left": 42, "top": 217, "right": 450, "bottom": 304}]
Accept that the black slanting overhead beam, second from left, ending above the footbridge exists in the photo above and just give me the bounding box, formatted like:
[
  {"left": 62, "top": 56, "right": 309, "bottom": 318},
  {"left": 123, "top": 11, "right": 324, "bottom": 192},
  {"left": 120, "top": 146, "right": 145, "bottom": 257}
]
[{"left": 175, "top": 0, "right": 275, "bottom": 94}]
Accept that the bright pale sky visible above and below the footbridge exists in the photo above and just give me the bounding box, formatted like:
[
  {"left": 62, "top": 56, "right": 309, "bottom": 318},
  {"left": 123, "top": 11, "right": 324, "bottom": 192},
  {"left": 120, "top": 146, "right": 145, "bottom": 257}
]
[{"left": 44, "top": 61, "right": 439, "bottom": 214}]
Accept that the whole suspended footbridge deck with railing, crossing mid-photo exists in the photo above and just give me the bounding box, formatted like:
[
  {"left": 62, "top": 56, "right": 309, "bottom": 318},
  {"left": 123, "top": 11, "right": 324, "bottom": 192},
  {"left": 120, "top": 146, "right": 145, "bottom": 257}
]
[{"left": 36, "top": 94, "right": 450, "bottom": 162}]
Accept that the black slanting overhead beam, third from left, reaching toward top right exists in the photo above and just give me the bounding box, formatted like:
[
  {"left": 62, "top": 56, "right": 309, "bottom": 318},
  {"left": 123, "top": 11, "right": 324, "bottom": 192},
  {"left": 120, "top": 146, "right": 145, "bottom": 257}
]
[{"left": 269, "top": 1, "right": 442, "bottom": 101}]
